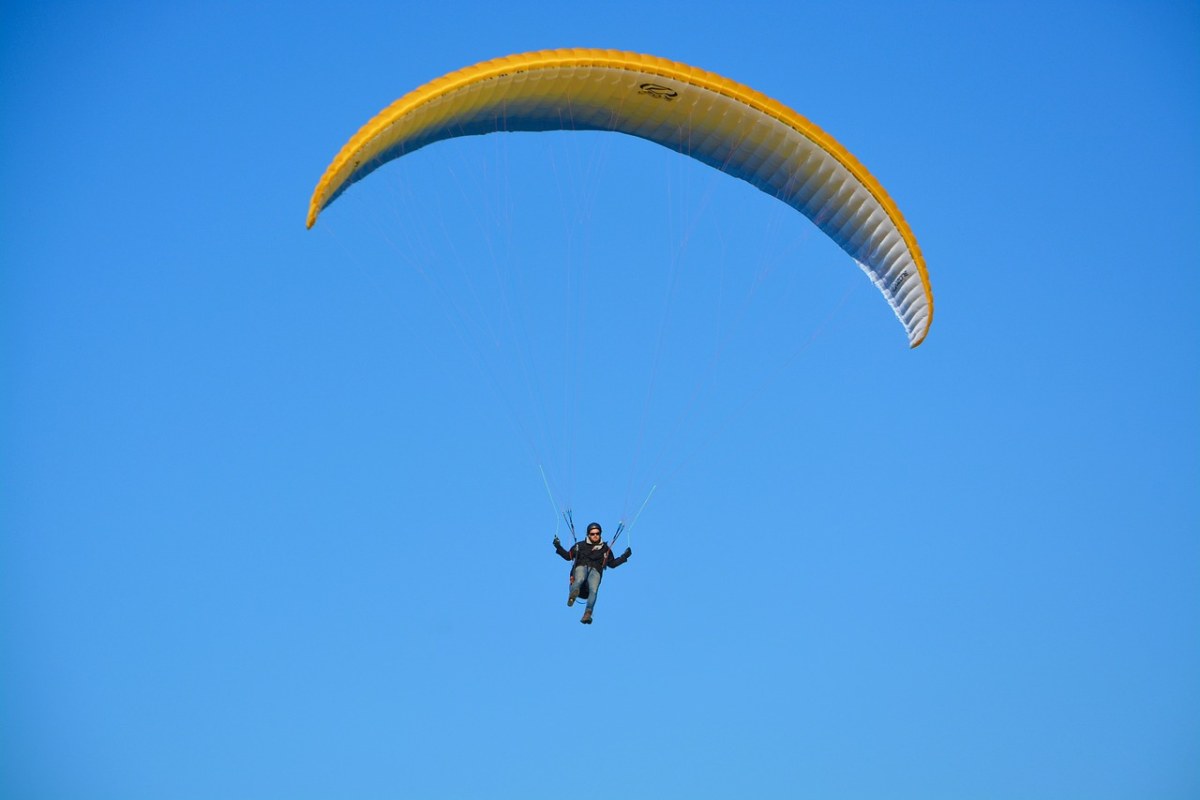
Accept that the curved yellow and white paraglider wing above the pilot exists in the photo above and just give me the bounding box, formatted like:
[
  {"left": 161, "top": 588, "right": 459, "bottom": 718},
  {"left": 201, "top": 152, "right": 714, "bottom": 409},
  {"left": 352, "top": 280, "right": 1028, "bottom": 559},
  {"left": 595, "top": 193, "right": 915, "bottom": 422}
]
[{"left": 307, "top": 49, "right": 934, "bottom": 347}]
